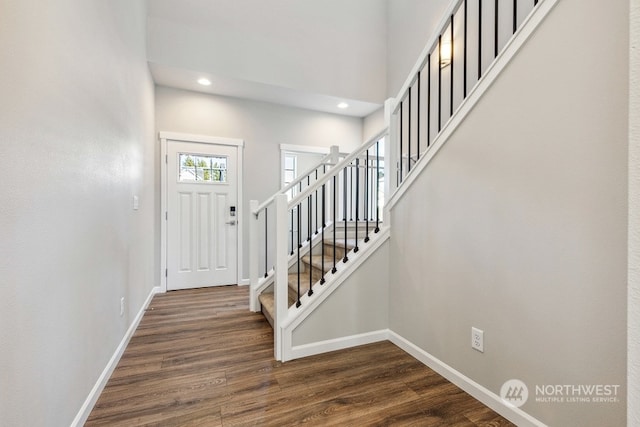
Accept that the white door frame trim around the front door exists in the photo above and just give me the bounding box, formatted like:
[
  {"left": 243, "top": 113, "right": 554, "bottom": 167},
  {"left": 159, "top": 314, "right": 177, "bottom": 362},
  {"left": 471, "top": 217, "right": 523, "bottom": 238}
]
[{"left": 158, "top": 131, "right": 245, "bottom": 292}]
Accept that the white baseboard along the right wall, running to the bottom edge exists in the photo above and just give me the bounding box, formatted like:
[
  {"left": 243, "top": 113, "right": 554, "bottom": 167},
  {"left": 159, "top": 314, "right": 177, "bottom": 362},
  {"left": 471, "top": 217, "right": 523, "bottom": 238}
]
[{"left": 388, "top": 331, "right": 546, "bottom": 427}]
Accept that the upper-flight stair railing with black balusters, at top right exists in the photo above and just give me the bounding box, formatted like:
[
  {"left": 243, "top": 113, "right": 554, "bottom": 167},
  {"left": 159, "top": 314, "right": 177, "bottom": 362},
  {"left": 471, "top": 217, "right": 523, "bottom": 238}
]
[{"left": 390, "top": 0, "right": 544, "bottom": 190}]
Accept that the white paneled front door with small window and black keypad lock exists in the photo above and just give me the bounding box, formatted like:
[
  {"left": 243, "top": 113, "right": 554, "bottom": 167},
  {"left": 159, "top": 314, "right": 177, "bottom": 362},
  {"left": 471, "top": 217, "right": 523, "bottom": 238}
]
[{"left": 166, "top": 140, "right": 238, "bottom": 290}]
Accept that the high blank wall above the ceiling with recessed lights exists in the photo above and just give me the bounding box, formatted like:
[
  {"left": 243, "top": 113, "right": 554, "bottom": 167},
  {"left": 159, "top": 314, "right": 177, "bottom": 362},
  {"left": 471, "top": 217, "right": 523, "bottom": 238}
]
[{"left": 149, "top": 0, "right": 386, "bottom": 103}]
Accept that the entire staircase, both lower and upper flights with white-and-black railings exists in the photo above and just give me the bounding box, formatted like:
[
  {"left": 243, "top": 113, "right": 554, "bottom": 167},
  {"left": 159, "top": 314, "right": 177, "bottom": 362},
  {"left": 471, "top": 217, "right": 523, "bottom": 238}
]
[{"left": 249, "top": 0, "right": 557, "bottom": 361}]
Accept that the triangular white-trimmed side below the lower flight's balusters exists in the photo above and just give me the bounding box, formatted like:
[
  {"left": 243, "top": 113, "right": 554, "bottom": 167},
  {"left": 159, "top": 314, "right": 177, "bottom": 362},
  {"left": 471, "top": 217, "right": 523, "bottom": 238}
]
[{"left": 279, "top": 226, "right": 390, "bottom": 362}]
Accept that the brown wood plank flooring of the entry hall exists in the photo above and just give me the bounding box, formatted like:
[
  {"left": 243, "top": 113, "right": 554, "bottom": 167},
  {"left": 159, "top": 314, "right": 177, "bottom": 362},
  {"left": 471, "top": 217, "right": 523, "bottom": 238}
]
[{"left": 85, "top": 286, "right": 513, "bottom": 427}]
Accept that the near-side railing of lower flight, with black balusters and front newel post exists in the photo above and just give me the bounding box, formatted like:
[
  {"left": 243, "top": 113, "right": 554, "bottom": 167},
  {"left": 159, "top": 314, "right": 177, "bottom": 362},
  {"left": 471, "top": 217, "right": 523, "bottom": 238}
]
[{"left": 273, "top": 129, "right": 388, "bottom": 360}]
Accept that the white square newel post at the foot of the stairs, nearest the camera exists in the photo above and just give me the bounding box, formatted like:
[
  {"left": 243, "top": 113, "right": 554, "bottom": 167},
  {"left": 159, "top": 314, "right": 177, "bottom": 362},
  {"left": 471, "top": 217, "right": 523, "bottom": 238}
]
[{"left": 273, "top": 194, "right": 289, "bottom": 360}]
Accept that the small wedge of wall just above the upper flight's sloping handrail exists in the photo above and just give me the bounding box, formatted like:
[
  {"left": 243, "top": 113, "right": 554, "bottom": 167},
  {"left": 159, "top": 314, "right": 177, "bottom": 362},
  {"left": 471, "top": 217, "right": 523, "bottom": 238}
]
[{"left": 386, "top": 0, "right": 451, "bottom": 97}]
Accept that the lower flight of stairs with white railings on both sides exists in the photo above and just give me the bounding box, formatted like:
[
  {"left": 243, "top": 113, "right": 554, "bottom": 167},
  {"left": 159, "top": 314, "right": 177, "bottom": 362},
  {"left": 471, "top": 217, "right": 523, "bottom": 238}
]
[{"left": 249, "top": 130, "right": 388, "bottom": 360}]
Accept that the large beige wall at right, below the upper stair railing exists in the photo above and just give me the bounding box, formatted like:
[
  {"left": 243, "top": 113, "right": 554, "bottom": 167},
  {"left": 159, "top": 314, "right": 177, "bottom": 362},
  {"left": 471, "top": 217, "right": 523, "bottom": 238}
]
[{"left": 389, "top": 0, "right": 629, "bottom": 426}]
